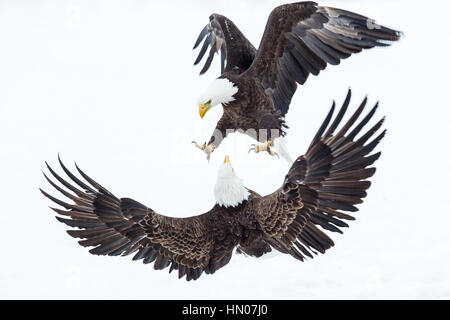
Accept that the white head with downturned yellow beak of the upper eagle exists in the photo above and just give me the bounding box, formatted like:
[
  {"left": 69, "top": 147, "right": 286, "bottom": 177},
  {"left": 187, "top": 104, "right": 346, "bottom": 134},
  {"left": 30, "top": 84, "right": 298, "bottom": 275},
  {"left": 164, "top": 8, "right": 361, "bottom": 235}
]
[{"left": 198, "top": 78, "right": 239, "bottom": 119}]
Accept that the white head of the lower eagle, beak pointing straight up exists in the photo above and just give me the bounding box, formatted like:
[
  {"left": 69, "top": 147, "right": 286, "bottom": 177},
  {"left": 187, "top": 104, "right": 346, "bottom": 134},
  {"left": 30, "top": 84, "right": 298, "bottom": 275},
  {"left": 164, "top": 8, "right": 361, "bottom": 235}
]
[{"left": 214, "top": 156, "right": 250, "bottom": 208}]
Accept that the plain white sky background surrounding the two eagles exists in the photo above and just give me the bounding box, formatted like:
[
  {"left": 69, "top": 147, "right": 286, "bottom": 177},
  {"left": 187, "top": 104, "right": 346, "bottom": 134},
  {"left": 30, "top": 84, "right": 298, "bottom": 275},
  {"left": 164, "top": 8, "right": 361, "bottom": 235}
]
[{"left": 0, "top": 0, "right": 450, "bottom": 299}]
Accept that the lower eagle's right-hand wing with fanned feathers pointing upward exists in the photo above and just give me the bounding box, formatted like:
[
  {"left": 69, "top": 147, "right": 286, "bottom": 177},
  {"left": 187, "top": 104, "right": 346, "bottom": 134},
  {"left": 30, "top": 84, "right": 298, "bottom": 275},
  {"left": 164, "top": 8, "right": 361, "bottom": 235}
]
[{"left": 255, "top": 91, "right": 386, "bottom": 260}]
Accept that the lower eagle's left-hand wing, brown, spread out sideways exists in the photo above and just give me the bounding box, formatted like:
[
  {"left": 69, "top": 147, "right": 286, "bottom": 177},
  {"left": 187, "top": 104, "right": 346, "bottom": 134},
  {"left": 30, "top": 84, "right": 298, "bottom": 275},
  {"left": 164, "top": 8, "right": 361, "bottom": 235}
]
[{"left": 41, "top": 160, "right": 236, "bottom": 281}]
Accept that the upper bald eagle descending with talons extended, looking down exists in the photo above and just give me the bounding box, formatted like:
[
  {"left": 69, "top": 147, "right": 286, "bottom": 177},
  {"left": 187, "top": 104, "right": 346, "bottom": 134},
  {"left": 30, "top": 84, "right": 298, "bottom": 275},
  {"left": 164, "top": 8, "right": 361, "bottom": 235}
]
[{"left": 193, "top": 1, "right": 400, "bottom": 161}]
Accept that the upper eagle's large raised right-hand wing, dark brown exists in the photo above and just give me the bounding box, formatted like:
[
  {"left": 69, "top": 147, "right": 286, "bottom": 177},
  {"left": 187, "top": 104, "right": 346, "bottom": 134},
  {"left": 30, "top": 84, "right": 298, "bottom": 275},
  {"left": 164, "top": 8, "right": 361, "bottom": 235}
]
[{"left": 247, "top": 2, "right": 400, "bottom": 115}]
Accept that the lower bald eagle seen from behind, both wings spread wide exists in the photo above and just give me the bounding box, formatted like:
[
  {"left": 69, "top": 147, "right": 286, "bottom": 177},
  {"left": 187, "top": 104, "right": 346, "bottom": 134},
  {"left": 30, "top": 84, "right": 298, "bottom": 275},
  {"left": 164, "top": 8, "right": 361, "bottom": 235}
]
[{"left": 41, "top": 92, "right": 385, "bottom": 281}]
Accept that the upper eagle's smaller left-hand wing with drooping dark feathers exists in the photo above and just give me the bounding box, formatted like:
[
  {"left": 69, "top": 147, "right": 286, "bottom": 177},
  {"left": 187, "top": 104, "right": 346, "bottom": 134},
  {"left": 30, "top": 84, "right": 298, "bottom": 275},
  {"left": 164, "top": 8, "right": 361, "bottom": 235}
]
[{"left": 194, "top": 14, "right": 256, "bottom": 74}]
